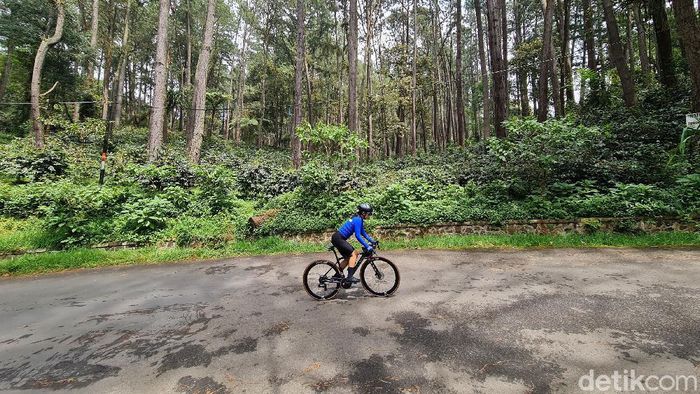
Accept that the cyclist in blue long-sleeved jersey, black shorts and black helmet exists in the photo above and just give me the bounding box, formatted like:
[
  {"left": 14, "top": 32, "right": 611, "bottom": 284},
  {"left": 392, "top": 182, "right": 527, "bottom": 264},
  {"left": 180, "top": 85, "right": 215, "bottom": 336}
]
[{"left": 331, "top": 203, "right": 376, "bottom": 283}]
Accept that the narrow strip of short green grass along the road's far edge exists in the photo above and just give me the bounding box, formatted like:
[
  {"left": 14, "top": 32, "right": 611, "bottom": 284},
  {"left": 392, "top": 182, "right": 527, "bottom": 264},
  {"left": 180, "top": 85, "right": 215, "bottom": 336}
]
[{"left": 0, "top": 232, "right": 700, "bottom": 276}]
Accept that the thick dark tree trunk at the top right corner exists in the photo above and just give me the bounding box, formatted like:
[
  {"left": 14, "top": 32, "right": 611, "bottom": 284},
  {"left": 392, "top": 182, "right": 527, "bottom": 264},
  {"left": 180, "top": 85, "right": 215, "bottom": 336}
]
[{"left": 673, "top": 0, "right": 700, "bottom": 112}]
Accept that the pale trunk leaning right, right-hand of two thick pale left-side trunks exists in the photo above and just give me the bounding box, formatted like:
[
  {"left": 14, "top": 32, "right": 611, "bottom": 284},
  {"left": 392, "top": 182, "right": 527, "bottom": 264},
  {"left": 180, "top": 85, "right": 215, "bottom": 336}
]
[{"left": 187, "top": 0, "right": 216, "bottom": 163}]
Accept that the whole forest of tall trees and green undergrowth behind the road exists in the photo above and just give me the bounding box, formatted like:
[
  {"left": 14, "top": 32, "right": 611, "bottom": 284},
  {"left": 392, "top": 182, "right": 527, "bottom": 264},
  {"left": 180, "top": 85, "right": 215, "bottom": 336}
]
[{"left": 0, "top": 0, "right": 700, "bottom": 253}]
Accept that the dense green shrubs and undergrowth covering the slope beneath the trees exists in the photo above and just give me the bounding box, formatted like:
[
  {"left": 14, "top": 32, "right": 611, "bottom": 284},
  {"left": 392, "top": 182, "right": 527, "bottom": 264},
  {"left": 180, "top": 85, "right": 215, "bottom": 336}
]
[{"left": 0, "top": 89, "right": 700, "bottom": 253}]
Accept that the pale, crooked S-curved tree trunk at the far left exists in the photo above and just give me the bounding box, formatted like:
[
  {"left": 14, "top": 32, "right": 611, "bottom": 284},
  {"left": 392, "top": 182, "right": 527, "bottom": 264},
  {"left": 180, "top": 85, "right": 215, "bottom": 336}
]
[{"left": 30, "top": 0, "right": 66, "bottom": 149}]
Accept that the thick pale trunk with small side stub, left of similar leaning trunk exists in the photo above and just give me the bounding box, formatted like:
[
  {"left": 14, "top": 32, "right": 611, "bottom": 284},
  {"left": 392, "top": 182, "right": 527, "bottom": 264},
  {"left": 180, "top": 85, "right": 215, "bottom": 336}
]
[{"left": 142, "top": 0, "right": 170, "bottom": 162}]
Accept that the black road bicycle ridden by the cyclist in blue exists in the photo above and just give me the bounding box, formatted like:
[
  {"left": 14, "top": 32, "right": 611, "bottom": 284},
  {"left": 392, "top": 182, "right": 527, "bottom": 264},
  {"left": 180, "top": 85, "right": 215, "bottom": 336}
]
[{"left": 303, "top": 242, "right": 401, "bottom": 300}]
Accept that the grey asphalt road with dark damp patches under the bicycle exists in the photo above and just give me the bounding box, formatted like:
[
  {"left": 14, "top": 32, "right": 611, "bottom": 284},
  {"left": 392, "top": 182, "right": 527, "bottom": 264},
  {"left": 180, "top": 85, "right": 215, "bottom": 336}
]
[{"left": 0, "top": 249, "right": 700, "bottom": 393}]
